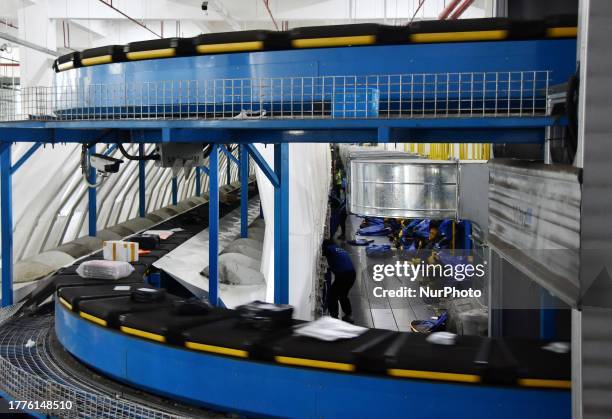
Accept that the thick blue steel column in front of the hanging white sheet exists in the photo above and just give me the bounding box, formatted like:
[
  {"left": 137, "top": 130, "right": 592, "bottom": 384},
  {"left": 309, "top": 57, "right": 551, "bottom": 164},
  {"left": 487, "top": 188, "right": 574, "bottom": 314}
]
[{"left": 274, "top": 143, "right": 289, "bottom": 304}]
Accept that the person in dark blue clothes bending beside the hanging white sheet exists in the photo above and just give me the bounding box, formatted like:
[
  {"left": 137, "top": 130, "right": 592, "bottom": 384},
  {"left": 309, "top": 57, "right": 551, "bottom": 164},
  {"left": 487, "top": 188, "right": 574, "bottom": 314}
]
[{"left": 323, "top": 240, "right": 357, "bottom": 323}]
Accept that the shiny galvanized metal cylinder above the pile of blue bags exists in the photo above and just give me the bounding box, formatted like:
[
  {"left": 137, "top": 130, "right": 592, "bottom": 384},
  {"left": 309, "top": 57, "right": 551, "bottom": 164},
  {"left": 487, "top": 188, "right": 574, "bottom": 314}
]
[{"left": 347, "top": 155, "right": 459, "bottom": 219}]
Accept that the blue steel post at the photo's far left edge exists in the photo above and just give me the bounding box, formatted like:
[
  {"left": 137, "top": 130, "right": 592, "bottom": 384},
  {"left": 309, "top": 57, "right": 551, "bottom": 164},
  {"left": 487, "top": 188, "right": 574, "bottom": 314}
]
[{"left": 0, "top": 143, "right": 13, "bottom": 307}]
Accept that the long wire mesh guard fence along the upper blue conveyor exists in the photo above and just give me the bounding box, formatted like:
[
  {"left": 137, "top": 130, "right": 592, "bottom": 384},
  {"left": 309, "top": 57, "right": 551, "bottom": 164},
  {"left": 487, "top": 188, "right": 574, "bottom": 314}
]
[{"left": 0, "top": 71, "right": 550, "bottom": 121}]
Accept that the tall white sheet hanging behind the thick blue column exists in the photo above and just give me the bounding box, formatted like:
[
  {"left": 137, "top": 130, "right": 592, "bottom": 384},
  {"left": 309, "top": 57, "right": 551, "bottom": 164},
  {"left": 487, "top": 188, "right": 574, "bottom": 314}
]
[{"left": 256, "top": 143, "right": 331, "bottom": 320}]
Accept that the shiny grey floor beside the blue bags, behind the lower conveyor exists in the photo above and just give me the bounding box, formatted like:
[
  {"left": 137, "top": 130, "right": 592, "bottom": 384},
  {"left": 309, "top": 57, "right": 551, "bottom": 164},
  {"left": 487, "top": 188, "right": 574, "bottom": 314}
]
[{"left": 336, "top": 215, "right": 435, "bottom": 331}]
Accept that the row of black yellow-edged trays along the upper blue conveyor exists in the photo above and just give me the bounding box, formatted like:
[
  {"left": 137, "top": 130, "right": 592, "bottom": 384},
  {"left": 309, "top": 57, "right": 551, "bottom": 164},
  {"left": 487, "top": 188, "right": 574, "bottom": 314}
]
[{"left": 53, "top": 16, "right": 577, "bottom": 72}]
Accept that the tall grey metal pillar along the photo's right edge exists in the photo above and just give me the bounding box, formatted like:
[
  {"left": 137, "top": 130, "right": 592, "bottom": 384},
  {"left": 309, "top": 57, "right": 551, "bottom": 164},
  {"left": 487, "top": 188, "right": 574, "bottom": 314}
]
[{"left": 572, "top": 0, "right": 612, "bottom": 419}]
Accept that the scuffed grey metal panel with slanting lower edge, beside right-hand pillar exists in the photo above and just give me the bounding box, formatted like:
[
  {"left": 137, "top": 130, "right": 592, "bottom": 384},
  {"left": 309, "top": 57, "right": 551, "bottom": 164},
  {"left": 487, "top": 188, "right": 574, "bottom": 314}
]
[{"left": 489, "top": 159, "right": 581, "bottom": 307}]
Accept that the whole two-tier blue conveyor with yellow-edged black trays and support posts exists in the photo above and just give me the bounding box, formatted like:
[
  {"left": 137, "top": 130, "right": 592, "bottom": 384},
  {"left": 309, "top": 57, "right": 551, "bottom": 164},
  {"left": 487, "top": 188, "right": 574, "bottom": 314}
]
[{"left": 0, "top": 17, "right": 576, "bottom": 419}]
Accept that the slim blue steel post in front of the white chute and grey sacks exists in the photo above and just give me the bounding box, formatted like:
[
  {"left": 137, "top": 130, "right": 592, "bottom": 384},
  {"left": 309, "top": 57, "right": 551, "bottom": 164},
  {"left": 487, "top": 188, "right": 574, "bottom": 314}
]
[{"left": 208, "top": 144, "right": 219, "bottom": 306}]
